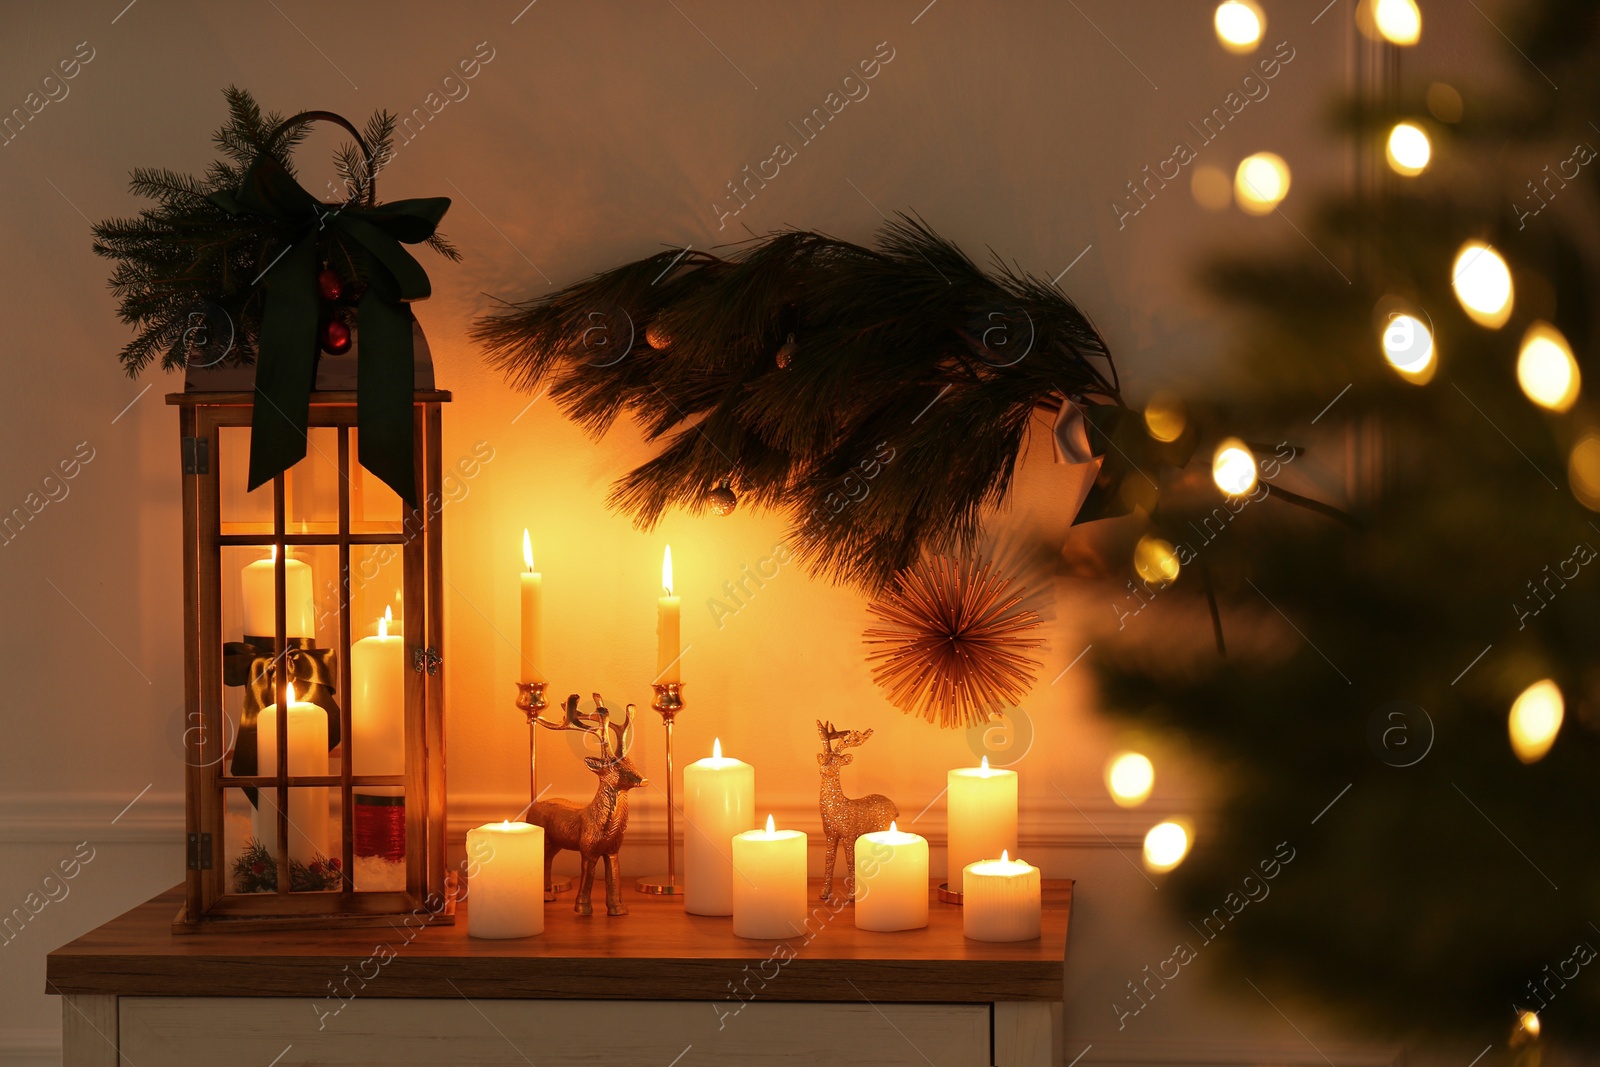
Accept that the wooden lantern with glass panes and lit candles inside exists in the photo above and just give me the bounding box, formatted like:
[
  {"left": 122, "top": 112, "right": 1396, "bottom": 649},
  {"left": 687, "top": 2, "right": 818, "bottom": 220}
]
[{"left": 168, "top": 347, "right": 453, "bottom": 929}]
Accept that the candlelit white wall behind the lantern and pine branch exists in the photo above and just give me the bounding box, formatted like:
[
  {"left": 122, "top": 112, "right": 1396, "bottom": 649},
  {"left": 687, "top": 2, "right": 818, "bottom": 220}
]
[{"left": 0, "top": 0, "right": 1478, "bottom": 1064}]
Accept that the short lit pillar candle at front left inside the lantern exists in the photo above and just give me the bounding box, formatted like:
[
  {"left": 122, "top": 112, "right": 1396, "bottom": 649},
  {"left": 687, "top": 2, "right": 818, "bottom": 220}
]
[{"left": 254, "top": 685, "right": 333, "bottom": 864}]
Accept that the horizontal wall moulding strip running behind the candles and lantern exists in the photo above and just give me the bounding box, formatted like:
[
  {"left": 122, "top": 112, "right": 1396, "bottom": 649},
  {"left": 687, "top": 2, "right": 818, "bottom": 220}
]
[{"left": 0, "top": 790, "right": 1171, "bottom": 851}]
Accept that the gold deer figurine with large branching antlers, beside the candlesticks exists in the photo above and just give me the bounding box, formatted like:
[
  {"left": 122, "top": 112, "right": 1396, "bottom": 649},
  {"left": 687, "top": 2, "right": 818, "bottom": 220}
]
[{"left": 528, "top": 693, "right": 646, "bottom": 915}]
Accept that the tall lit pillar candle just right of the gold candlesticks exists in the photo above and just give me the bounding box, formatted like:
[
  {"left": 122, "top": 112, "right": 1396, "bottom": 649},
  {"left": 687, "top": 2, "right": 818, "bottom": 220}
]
[{"left": 683, "top": 739, "right": 755, "bottom": 915}]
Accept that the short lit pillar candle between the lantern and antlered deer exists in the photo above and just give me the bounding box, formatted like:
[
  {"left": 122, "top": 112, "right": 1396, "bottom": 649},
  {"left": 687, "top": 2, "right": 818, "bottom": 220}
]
[{"left": 467, "top": 822, "right": 544, "bottom": 937}]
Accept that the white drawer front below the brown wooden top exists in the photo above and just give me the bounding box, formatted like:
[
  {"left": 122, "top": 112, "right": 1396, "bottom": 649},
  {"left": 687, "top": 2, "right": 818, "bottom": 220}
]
[{"left": 118, "top": 997, "right": 990, "bottom": 1067}]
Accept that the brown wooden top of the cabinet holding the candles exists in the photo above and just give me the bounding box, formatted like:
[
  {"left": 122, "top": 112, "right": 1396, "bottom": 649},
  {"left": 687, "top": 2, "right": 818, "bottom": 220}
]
[{"left": 45, "top": 880, "right": 1072, "bottom": 1003}]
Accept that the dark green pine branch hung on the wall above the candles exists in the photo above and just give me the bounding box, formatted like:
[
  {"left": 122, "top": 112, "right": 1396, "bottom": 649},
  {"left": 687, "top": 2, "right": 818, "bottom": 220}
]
[{"left": 474, "top": 216, "right": 1120, "bottom": 589}]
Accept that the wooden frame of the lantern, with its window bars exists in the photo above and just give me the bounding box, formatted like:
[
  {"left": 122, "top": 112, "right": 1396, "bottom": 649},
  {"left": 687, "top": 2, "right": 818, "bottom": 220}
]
[{"left": 166, "top": 389, "right": 454, "bottom": 931}]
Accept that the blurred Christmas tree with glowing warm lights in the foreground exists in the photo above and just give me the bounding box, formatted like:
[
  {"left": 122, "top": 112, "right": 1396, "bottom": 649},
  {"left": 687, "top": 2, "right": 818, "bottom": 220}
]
[{"left": 1094, "top": 0, "right": 1600, "bottom": 1065}]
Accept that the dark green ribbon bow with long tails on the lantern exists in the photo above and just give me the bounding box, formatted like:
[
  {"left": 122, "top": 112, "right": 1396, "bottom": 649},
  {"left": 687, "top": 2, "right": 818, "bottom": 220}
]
[{"left": 208, "top": 155, "right": 450, "bottom": 507}]
